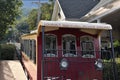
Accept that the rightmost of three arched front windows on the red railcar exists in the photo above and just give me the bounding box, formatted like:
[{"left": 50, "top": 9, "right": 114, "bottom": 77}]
[{"left": 80, "top": 36, "right": 95, "bottom": 58}]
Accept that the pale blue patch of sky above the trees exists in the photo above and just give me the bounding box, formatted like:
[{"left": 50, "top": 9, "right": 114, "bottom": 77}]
[{"left": 22, "top": 0, "right": 48, "bottom": 8}]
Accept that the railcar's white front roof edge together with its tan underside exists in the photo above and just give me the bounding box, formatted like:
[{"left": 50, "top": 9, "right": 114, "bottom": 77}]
[{"left": 37, "top": 20, "right": 112, "bottom": 35}]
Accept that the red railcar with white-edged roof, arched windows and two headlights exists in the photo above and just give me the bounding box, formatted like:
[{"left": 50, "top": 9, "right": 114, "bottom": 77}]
[{"left": 21, "top": 21, "right": 112, "bottom": 80}]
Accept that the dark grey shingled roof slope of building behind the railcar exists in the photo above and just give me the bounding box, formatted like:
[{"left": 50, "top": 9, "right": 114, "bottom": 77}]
[{"left": 58, "top": 0, "right": 100, "bottom": 19}]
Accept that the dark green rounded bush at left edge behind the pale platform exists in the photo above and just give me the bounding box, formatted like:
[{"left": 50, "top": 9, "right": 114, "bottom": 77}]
[{"left": 0, "top": 44, "right": 16, "bottom": 60}]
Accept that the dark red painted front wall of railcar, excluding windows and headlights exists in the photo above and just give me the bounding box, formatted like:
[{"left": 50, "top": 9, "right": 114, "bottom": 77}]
[{"left": 37, "top": 28, "right": 102, "bottom": 80}]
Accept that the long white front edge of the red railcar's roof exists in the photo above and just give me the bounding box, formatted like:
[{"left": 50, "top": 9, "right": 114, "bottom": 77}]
[{"left": 38, "top": 20, "right": 112, "bottom": 30}]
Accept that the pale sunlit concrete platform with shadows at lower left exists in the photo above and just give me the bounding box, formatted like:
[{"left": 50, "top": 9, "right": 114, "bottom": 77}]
[{"left": 0, "top": 60, "right": 27, "bottom": 80}]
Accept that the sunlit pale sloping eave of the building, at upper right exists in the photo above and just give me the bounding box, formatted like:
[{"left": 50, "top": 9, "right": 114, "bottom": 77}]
[{"left": 80, "top": 0, "right": 120, "bottom": 23}]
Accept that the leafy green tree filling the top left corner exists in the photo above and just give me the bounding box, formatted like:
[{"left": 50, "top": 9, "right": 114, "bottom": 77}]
[{"left": 0, "top": 0, "right": 22, "bottom": 37}]
